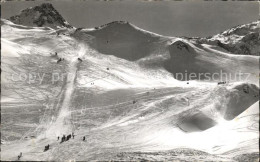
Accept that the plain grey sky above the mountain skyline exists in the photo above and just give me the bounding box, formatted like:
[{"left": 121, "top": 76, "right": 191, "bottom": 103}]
[{"left": 1, "top": 0, "right": 259, "bottom": 37}]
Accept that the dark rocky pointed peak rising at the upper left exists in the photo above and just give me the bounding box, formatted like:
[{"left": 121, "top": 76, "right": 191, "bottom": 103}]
[{"left": 9, "top": 3, "right": 72, "bottom": 28}]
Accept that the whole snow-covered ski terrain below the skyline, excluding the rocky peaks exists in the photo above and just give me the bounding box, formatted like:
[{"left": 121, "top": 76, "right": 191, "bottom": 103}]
[{"left": 1, "top": 3, "right": 259, "bottom": 161}]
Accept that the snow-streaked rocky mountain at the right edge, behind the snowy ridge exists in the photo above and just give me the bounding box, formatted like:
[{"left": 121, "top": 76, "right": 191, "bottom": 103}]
[{"left": 197, "top": 20, "right": 260, "bottom": 56}]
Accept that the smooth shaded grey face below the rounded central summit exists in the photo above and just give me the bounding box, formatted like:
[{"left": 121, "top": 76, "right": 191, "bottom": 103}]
[{"left": 72, "top": 21, "right": 168, "bottom": 61}]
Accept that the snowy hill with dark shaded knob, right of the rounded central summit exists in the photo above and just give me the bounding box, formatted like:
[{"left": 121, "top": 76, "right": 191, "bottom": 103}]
[{"left": 164, "top": 39, "right": 259, "bottom": 84}]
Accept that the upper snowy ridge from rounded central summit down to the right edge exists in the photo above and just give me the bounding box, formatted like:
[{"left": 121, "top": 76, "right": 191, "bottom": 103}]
[{"left": 71, "top": 22, "right": 259, "bottom": 84}]
